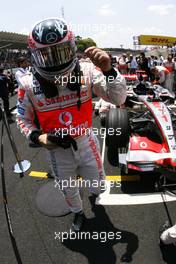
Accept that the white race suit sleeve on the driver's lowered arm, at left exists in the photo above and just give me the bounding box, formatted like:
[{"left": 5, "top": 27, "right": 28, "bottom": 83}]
[{"left": 16, "top": 89, "right": 39, "bottom": 139}]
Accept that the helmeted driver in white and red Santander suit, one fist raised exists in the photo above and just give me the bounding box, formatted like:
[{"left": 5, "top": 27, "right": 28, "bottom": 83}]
[{"left": 17, "top": 19, "right": 126, "bottom": 231}]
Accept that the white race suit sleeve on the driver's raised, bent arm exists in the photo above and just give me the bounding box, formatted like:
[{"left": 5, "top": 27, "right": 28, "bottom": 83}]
[{"left": 92, "top": 64, "right": 126, "bottom": 106}]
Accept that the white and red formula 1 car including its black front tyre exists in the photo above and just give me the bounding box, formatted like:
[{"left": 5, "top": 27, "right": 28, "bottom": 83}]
[{"left": 97, "top": 72, "right": 176, "bottom": 188}]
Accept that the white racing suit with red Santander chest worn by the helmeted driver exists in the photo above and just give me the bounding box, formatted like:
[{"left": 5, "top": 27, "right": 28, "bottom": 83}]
[{"left": 17, "top": 62, "right": 126, "bottom": 213}]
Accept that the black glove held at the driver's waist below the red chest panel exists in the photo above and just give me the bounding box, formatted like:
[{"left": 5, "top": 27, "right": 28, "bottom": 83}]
[{"left": 47, "top": 134, "right": 78, "bottom": 151}]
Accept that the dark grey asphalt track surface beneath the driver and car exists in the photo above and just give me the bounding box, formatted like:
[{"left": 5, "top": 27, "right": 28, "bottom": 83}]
[{"left": 0, "top": 97, "right": 176, "bottom": 264}]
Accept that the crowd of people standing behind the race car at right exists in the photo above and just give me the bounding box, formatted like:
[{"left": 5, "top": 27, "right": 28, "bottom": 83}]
[{"left": 114, "top": 52, "right": 176, "bottom": 91}]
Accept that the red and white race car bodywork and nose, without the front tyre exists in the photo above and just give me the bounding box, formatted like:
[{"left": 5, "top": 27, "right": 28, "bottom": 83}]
[{"left": 118, "top": 86, "right": 176, "bottom": 176}]
